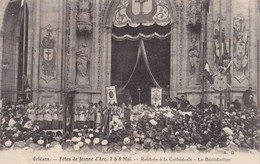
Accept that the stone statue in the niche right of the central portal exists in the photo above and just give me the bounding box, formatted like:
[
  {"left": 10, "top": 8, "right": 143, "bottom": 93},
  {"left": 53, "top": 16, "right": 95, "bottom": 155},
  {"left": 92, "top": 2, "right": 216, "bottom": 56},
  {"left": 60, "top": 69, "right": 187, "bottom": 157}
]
[{"left": 188, "top": 34, "right": 200, "bottom": 75}]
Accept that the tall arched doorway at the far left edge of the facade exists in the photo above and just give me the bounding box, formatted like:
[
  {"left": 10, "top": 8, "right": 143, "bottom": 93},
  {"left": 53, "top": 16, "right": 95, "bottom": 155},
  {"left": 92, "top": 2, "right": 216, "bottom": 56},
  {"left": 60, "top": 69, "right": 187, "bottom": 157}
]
[{"left": 1, "top": 1, "right": 28, "bottom": 103}]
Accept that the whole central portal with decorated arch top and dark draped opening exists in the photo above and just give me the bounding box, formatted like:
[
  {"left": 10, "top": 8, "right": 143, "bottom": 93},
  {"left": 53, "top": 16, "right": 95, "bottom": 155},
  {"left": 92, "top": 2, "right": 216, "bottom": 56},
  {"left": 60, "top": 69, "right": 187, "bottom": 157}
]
[{"left": 103, "top": 0, "right": 178, "bottom": 105}]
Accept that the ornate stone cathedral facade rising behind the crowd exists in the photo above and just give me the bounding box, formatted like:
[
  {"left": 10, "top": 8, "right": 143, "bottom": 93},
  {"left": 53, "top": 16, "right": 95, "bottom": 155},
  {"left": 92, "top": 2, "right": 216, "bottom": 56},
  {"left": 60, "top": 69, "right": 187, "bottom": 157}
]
[{"left": 0, "top": 0, "right": 260, "bottom": 107}]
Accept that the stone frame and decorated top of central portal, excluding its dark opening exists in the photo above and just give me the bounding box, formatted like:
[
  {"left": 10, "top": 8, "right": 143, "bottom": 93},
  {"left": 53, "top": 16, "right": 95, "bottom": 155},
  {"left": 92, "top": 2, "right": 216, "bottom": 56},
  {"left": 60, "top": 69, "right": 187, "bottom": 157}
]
[{"left": 101, "top": 0, "right": 179, "bottom": 103}]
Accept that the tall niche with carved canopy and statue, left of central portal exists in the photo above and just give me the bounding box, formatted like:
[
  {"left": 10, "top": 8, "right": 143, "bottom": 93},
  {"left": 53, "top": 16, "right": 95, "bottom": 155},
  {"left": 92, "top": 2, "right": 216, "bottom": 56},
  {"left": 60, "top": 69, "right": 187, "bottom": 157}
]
[{"left": 75, "top": 0, "right": 93, "bottom": 89}]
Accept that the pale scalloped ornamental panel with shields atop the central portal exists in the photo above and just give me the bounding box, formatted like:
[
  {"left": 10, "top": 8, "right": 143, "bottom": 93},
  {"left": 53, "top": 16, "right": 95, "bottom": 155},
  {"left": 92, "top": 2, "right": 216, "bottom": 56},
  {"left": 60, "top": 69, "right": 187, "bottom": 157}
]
[{"left": 113, "top": 0, "right": 171, "bottom": 27}]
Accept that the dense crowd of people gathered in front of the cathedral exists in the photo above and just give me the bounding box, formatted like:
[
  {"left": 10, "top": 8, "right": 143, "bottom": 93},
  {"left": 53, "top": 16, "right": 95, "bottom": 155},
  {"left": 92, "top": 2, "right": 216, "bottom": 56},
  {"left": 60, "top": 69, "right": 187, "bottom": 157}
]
[{"left": 0, "top": 96, "right": 260, "bottom": 153}]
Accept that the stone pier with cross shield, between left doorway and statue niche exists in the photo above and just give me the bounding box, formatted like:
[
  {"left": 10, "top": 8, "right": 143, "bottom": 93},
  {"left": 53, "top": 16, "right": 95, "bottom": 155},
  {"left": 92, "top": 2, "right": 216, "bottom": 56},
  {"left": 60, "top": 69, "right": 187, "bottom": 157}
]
[{"left": 32, "top": 0, "right": 64, "bottom": 103}]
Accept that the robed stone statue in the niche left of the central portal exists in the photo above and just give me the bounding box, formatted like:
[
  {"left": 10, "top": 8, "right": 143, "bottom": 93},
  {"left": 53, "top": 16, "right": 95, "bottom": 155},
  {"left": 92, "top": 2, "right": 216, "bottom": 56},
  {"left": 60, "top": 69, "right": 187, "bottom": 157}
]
[{"left": 76, "top": 43, "right": 90, "bottom": 85}]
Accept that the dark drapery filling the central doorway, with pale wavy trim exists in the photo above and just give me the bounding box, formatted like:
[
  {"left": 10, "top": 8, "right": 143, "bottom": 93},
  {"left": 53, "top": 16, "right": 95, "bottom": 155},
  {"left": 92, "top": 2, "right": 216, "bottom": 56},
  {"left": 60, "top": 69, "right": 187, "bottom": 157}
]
[{"left": 111, "top": 24, "right": 170, "bottom": 105}]
